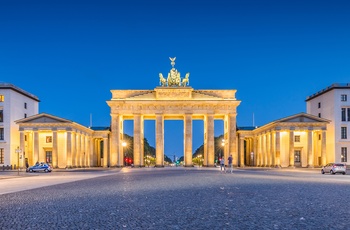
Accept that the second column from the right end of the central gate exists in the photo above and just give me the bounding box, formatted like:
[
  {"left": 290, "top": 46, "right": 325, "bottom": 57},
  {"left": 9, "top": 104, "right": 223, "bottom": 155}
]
[{"left": 203, "top": 114, "right": 215, "bottom": 167}]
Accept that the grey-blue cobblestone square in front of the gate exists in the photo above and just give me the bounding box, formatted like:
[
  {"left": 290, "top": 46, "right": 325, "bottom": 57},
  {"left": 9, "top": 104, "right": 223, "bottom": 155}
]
[{"left": 0, "top": 168, "right": 350, "bottom": 229}]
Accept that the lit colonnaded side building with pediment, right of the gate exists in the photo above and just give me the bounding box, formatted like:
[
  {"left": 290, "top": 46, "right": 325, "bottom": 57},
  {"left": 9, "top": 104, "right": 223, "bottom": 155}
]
[{"left": 238, "top": 113, "right": 330, "bottom": 168}]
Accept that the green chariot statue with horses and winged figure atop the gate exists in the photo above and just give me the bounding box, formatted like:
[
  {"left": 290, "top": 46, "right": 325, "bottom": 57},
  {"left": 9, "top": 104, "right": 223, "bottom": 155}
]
[{"left": 159, "top": 57, "right": 190, "bottom": 87}]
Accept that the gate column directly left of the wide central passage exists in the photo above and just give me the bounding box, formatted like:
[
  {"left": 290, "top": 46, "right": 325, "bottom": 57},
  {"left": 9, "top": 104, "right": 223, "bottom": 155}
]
[{"left": 156, "top": 114, "right": 164, "bottom": 167}]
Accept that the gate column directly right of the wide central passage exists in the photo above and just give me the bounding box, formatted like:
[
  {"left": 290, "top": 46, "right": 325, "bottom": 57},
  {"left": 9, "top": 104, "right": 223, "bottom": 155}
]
[{"left": 184, "top": 114, "right": 192, "bottom": 167}]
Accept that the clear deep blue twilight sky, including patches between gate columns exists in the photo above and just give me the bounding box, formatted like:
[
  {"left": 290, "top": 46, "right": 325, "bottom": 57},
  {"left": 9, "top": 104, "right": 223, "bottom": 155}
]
[{"left": 0, "top": 0, "right": 350, "bottom": 156}]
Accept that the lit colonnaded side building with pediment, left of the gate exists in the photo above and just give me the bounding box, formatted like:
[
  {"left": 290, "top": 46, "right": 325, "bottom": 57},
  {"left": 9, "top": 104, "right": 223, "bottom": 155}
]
[{"left": 16, "top": 113, "right": 109, "bottom": 168}]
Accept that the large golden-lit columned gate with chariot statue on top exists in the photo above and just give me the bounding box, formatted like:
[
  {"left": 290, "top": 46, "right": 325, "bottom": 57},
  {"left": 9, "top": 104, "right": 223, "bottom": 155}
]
[{"left": 107, "top": 58, "right": 240, "bottom": 167}]
